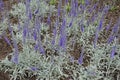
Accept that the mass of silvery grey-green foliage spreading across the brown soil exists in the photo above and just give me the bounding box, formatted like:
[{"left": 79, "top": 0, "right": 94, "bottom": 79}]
[{"left": 0, "top": 0, "right": 120, "bottom": 80}]
